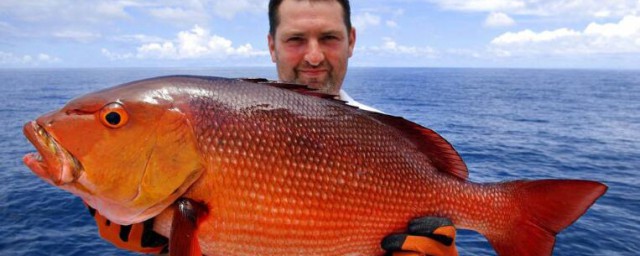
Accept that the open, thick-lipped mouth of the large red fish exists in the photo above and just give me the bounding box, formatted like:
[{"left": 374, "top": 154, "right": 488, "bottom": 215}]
[{"left": 22, "top": 121, "right": 83, "bottom": 186}]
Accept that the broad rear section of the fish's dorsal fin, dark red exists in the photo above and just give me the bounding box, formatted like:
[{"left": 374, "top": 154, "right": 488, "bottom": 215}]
[{"left": 368, "top": 112, "right": 469, "bottom": 180}]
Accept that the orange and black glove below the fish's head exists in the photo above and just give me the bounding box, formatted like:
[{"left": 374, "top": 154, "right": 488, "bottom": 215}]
[{"left": 85, "top": 203, "right": 169, "bottom": 254}]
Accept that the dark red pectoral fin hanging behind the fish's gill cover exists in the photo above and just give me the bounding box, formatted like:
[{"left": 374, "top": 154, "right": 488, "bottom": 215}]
[{"left": 169, "top": 198, "right": 206, "bottom": 256}]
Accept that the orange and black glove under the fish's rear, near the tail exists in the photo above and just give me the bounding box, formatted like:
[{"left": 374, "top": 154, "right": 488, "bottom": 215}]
[{"left": 381, "top": 217, "right": 458, "bottom": 256}]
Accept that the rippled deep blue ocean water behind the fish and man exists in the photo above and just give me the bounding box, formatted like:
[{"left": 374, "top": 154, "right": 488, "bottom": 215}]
[{"left": 0, "top": 68, "right": 640, "bottom": 255}]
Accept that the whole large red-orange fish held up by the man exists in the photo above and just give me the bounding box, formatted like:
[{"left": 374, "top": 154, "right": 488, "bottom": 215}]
[{"left": 24, "top": 76, "right": 606, "bottom": 255}]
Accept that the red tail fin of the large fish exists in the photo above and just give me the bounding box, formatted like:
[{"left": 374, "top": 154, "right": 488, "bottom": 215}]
[{"left": 485, "top": 180, "right": 607, "bottom": 256}]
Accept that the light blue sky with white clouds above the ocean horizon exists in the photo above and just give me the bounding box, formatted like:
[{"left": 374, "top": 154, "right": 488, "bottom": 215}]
[{"left": 0, "top": 0, "right": 640, "bottom": 69}]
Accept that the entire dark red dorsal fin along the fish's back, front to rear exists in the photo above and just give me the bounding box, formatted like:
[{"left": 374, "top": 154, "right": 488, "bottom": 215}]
[{"left": 240, "top": 78, "right": 469, "bottom": 180}]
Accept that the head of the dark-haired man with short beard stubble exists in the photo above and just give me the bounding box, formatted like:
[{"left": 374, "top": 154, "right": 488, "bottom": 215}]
[{"left": 268, "top": 0, "right": 356, "bottom": 95}]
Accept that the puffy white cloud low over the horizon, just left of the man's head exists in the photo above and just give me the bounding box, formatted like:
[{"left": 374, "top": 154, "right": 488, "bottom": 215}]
[{"left": 102, "top": 26, "right": 269, "bottom": 60}]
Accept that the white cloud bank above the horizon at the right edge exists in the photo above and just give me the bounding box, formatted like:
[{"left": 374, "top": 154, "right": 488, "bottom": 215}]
[{"left": 491, "top": 16, "right": 640, "bottom": 56}]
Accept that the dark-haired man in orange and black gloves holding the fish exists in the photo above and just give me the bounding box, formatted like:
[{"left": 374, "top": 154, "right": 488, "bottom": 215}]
[{"left": 91, "top": 0, "right": 457, "bottom": 255}]
